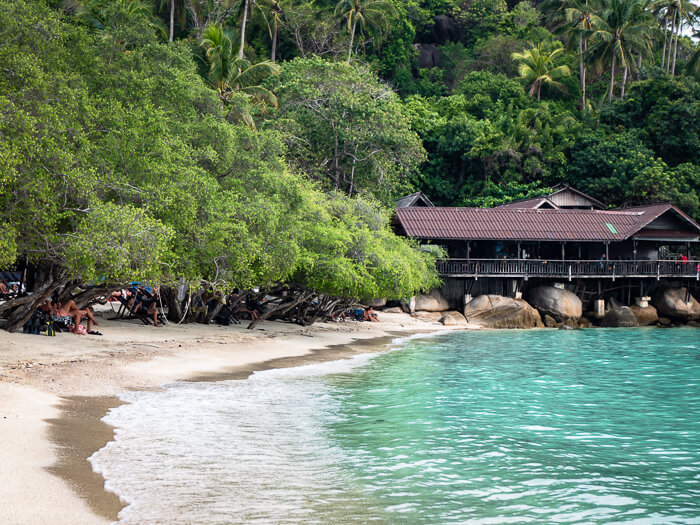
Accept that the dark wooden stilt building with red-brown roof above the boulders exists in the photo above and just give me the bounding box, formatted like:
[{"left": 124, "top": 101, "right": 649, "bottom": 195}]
[{"left": 394, "top": 186, "right": 700, "bottom": 308}]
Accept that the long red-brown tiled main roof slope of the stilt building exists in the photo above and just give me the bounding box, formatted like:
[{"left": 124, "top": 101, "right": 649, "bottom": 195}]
[{"left": 396, "top": 204, "right": 700, "bottom": 241}]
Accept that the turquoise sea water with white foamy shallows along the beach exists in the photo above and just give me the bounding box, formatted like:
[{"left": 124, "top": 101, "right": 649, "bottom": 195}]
[{"left": 91, "top": 329, "right": 700, "bottom": 524}]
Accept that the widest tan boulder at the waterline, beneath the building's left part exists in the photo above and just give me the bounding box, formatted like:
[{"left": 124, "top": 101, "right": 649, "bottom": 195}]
[{"left": 464, "top": 295, "right": 544, "bottom": 328}]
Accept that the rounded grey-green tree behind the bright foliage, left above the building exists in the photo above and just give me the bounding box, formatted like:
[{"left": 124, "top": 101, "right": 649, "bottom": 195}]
[{"left": 266, "top": 58, "right": 424, "bottom": 204}]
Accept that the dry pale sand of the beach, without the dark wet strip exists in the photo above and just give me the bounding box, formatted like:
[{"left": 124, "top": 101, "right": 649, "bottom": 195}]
[{"left": 0, "top": 312, "right": 476, "bottom": 524}]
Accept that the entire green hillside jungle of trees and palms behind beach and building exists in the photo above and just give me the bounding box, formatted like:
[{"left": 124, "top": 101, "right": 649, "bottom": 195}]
[{"left": 0, "top": 0, "right": 700, "bottom": 326}]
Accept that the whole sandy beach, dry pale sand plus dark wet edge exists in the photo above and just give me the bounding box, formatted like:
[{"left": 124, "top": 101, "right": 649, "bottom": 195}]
[{"left": 0, "top": 309, "right": 476, "bottom": 525}]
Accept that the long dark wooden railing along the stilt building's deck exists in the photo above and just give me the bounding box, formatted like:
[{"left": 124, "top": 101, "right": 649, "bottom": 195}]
[{"left": 437, "top": 259, "right": 700, "bottom": 280}]
